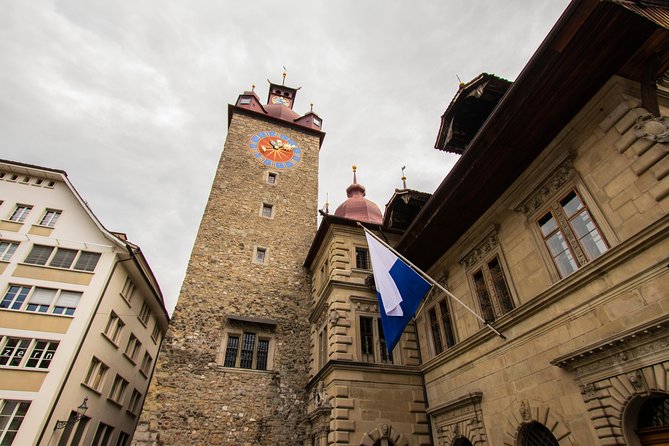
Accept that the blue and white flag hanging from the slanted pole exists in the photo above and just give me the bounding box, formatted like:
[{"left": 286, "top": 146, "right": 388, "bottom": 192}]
[{"left": 365, "top": 230, "right": 432, "bottom": 352}]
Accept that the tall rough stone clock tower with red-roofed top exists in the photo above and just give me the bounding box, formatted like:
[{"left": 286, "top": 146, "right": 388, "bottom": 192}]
[{"left": 133, "top": 81, "right": 325, "bottom": 446}]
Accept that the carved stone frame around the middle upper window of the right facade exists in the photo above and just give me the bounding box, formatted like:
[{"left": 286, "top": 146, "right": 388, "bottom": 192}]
[{"left": 460, "top": 230, "right": 519, "bottom": 326}]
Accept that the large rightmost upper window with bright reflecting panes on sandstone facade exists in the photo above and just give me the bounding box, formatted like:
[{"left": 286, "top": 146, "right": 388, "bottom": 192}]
[{"left": 537, "top": 190, "right": 609, "bottom": 278}]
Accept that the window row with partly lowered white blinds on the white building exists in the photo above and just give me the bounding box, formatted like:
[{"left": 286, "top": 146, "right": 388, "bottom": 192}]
[{"left": 0, "top": 284, "right": 82, "bottom": 316}]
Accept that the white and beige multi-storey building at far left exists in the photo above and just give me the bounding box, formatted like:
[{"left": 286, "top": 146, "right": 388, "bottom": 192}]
[{"left": 0, "top": 161, "right": 169, "bottom": 446}]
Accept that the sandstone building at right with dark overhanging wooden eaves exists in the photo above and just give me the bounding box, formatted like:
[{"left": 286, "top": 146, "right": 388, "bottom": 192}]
[{"left": 397, "top": 1, "right": 669, "bottom": 446}]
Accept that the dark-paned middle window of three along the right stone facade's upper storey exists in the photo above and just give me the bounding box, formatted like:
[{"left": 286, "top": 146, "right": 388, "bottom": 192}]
[{"left": 472, "top": 256, "right": 513, "bottom": 322}]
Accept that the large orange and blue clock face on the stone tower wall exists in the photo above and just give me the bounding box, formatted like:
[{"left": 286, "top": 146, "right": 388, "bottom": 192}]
[{"left": 249, "top": 131, "right": 302, "bottom": 169}]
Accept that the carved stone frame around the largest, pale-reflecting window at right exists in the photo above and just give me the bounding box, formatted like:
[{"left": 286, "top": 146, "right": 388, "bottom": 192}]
[{"left": 514, "top": 156, "right": 619, "bottom": 283}]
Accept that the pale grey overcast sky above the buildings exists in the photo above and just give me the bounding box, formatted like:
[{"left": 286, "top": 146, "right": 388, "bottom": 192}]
[{"left": 0, "top": 0, "right": 568, "bottom": 312}]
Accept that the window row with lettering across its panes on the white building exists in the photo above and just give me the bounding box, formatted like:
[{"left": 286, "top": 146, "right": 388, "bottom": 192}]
[{"left": 0, "top": 336, "right": 58, "bottom": 369}]
